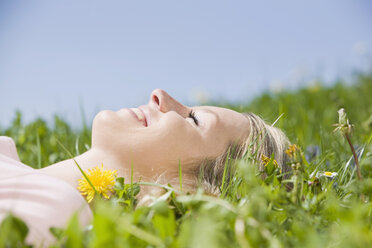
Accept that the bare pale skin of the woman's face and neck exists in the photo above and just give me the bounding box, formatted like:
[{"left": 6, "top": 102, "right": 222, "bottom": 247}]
[{"left": 40, "top": 89, "right": 249, "bottom": 190}]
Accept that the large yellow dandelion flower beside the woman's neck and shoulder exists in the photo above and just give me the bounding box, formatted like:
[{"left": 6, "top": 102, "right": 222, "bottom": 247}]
[{"left": 77, "top": 165, "right": 117, "bottom": 202}]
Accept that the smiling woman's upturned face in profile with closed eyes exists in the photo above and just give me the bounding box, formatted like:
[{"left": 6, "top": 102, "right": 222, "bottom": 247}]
[{"left": 92, "top": 89, "right": 249, "bottom": 172}]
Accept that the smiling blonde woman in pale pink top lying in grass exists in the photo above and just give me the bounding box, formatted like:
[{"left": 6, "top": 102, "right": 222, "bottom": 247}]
[{"left": 0, "top": 89, "right": 289, "bottom": 243}]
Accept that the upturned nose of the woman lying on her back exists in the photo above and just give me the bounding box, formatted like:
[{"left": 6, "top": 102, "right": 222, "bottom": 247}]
[{"left": 150, "top": 89, "right": 189, "bottom": 117}]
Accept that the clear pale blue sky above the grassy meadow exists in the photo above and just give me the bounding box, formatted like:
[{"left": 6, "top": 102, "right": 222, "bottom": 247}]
[{"left": 0, "top": 0, "right": 372, "bottom": 127}]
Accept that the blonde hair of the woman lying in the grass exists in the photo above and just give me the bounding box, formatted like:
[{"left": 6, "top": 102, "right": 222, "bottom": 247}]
[{"left": 195, "top": 113, "right": 290, "bottom": 195}]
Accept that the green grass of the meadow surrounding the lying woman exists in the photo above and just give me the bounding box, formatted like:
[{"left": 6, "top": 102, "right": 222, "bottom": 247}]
[{"left": 0, "top": 72, "right": 372, "bottom": 247}]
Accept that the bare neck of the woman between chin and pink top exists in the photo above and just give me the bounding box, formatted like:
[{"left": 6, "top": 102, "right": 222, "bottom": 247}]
[{"left": 40, "top": 149, "right": 154, "bottom": 188}]
